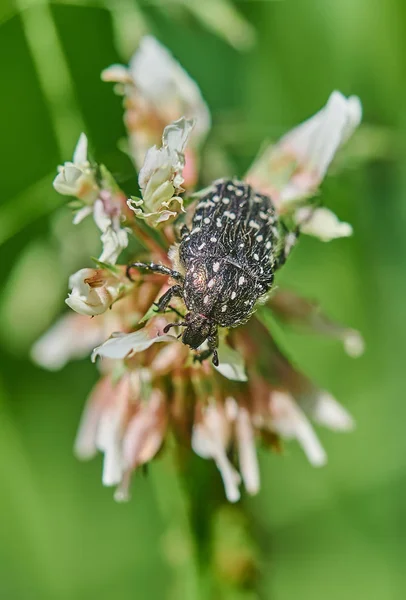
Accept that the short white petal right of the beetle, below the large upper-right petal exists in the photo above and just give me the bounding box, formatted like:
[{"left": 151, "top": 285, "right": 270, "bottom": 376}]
[{"left": 295, "top": 207, "right": 352, "bottom": 242}]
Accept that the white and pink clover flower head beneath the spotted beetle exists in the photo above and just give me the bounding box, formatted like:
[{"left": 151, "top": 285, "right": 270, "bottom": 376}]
[{"left": 33, "top": 48, "right": 363, "bottom": 502}]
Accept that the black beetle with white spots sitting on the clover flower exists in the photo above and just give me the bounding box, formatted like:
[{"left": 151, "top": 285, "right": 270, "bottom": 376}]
[{"left": 127, "top": 180, "right": 299, "bottom": 366}]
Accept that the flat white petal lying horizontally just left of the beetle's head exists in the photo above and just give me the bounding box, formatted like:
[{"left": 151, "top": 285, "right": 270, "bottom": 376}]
[{"left": 92, "top": 329, "right": 176, "bottom": 362}]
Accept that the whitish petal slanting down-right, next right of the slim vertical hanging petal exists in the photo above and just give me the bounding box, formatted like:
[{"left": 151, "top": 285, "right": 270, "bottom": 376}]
[{"left": 270, "top": 391, "right": 327, "bottom": 467}]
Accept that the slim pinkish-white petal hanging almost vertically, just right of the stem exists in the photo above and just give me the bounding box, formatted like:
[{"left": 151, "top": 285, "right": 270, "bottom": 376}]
[{"left": 235, "top": 406, "right": 260, "bottom": 495}]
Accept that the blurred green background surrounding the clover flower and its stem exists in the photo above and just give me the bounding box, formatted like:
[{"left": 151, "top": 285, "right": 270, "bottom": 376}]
[{"left": 0, "top": 0, "right": 406, "bottom": 600}]
